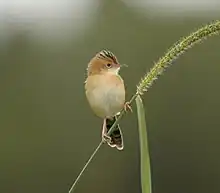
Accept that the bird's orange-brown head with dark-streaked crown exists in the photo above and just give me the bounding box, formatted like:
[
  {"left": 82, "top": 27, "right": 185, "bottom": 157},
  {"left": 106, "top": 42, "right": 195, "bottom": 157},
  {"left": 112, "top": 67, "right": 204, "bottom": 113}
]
[{"left": 87, "top": 50, "right": 120, "bottom": 76}]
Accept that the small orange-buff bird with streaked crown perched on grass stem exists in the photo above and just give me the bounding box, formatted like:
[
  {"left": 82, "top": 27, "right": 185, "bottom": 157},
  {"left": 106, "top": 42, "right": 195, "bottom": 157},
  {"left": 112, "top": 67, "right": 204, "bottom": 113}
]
[{"left": 85, "top": 50, "right": 131, "bottom": 150}]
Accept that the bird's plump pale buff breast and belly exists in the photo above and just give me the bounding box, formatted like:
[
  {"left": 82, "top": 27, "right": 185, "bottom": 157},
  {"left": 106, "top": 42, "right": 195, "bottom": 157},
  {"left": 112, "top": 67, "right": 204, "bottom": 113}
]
[{"left": 85, "top": 75, "right": 125, "bottom": 118}]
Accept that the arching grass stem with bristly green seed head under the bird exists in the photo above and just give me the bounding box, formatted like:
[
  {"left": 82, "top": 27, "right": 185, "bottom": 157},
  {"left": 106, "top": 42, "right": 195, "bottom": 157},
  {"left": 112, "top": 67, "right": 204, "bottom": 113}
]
[{"left": 69, "top": 20, "right": 220, "bottom": 193}]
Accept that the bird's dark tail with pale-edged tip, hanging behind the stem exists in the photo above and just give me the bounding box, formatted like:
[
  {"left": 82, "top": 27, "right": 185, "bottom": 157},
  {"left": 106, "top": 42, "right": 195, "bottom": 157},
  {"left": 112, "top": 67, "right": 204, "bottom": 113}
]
[{"left": 105, "top": 116, "right": 124, "bottom": 150}]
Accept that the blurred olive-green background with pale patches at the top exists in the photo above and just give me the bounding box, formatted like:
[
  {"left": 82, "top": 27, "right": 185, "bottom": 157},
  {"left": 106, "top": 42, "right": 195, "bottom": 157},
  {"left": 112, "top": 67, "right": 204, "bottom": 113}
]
[{"left": 0, "top": 0, "right": 220, "bottom": 193}]
